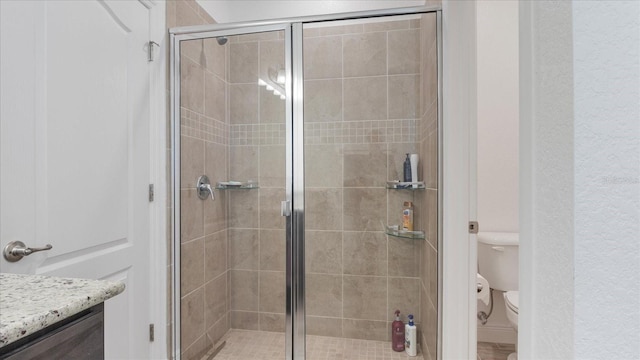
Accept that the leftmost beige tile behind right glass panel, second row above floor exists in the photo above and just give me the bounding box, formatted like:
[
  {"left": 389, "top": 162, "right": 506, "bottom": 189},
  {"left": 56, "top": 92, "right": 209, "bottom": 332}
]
[{"left": 305, "top": 274, "right": 343, "bottom": 317}]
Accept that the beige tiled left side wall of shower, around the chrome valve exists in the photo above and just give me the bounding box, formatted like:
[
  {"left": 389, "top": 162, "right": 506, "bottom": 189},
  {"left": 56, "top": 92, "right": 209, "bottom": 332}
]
[{"left": 167, "top": 0, "right": 229, "bottom": 359}]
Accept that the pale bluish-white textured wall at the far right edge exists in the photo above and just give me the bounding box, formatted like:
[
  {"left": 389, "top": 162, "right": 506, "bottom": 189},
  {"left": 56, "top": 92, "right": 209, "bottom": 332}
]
[{"left": 573, "top": 1, "right": 640, "bottom": 359}]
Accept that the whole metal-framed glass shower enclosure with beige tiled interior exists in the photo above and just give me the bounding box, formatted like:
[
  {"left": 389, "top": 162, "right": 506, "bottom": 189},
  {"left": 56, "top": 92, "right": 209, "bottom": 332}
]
[{"left": 170, "top": 8, "right": 442, "bottom": 359}]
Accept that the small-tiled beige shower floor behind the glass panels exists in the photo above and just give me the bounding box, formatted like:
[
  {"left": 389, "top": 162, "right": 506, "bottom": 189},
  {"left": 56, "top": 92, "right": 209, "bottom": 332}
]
[{"left": 208, "top": 329, "right": 423, "bottom": 360}]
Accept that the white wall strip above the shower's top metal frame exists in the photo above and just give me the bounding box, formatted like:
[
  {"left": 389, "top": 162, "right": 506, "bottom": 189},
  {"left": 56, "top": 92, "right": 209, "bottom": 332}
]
[{"left": 196, "top": 0, "right": 425, "bottom": 23}]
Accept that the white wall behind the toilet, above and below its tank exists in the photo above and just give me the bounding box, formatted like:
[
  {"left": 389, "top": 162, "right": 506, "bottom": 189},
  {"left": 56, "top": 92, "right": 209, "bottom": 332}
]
[{"left": 477, "top": 0, "right": 519, "bottom": 344}]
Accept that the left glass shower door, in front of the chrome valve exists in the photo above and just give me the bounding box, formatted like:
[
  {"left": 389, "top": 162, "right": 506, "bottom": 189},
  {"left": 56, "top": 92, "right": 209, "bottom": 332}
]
[{"left": 174, "top": 25, "right": 290, "bottom": 359}]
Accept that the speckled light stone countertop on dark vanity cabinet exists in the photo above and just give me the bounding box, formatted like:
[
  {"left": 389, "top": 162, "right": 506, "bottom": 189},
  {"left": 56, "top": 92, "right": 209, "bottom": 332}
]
[{"left": 0, "top": 273, "right": 124, "bottom": 348}]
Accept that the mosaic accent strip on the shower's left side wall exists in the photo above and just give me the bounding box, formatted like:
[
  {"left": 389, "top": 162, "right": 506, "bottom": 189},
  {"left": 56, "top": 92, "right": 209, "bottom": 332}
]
[{"left": 180, "top": 108, "right": 229, "bottom": 145}]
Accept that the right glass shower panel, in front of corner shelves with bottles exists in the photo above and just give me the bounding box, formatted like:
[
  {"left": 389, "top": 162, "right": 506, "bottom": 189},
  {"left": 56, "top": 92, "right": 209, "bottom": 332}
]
[{"left": 303, "top": 13, "right": 437, "bottom": 359}]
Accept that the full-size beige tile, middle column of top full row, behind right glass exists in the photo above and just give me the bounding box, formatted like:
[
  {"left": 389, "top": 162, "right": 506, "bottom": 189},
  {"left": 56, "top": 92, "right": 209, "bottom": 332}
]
[{"left": 342, "top": 32, "right": 387, "bottom": 77}]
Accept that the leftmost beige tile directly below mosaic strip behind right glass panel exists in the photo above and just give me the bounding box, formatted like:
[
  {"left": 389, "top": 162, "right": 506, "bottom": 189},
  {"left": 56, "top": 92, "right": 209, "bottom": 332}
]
[{"left": 304, "top": 144, "right": 343, "bottom": 188}]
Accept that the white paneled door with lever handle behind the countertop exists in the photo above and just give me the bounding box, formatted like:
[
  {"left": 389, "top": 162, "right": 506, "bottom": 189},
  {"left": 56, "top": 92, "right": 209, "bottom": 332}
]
[{"left": 0, "top": 0, "right": 150, "bottom": 359}]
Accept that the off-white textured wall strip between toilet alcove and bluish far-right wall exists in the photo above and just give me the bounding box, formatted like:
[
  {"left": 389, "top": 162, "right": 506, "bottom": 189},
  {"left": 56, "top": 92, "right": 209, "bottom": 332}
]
[{"left": 518, "top": 1, "right": 576, "bottom": 359}]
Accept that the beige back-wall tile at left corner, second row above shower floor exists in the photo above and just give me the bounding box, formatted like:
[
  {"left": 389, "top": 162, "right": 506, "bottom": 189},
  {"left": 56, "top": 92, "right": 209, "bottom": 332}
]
[{"left": 229, "top": 270, "right": 259, "bottom": 310}]
